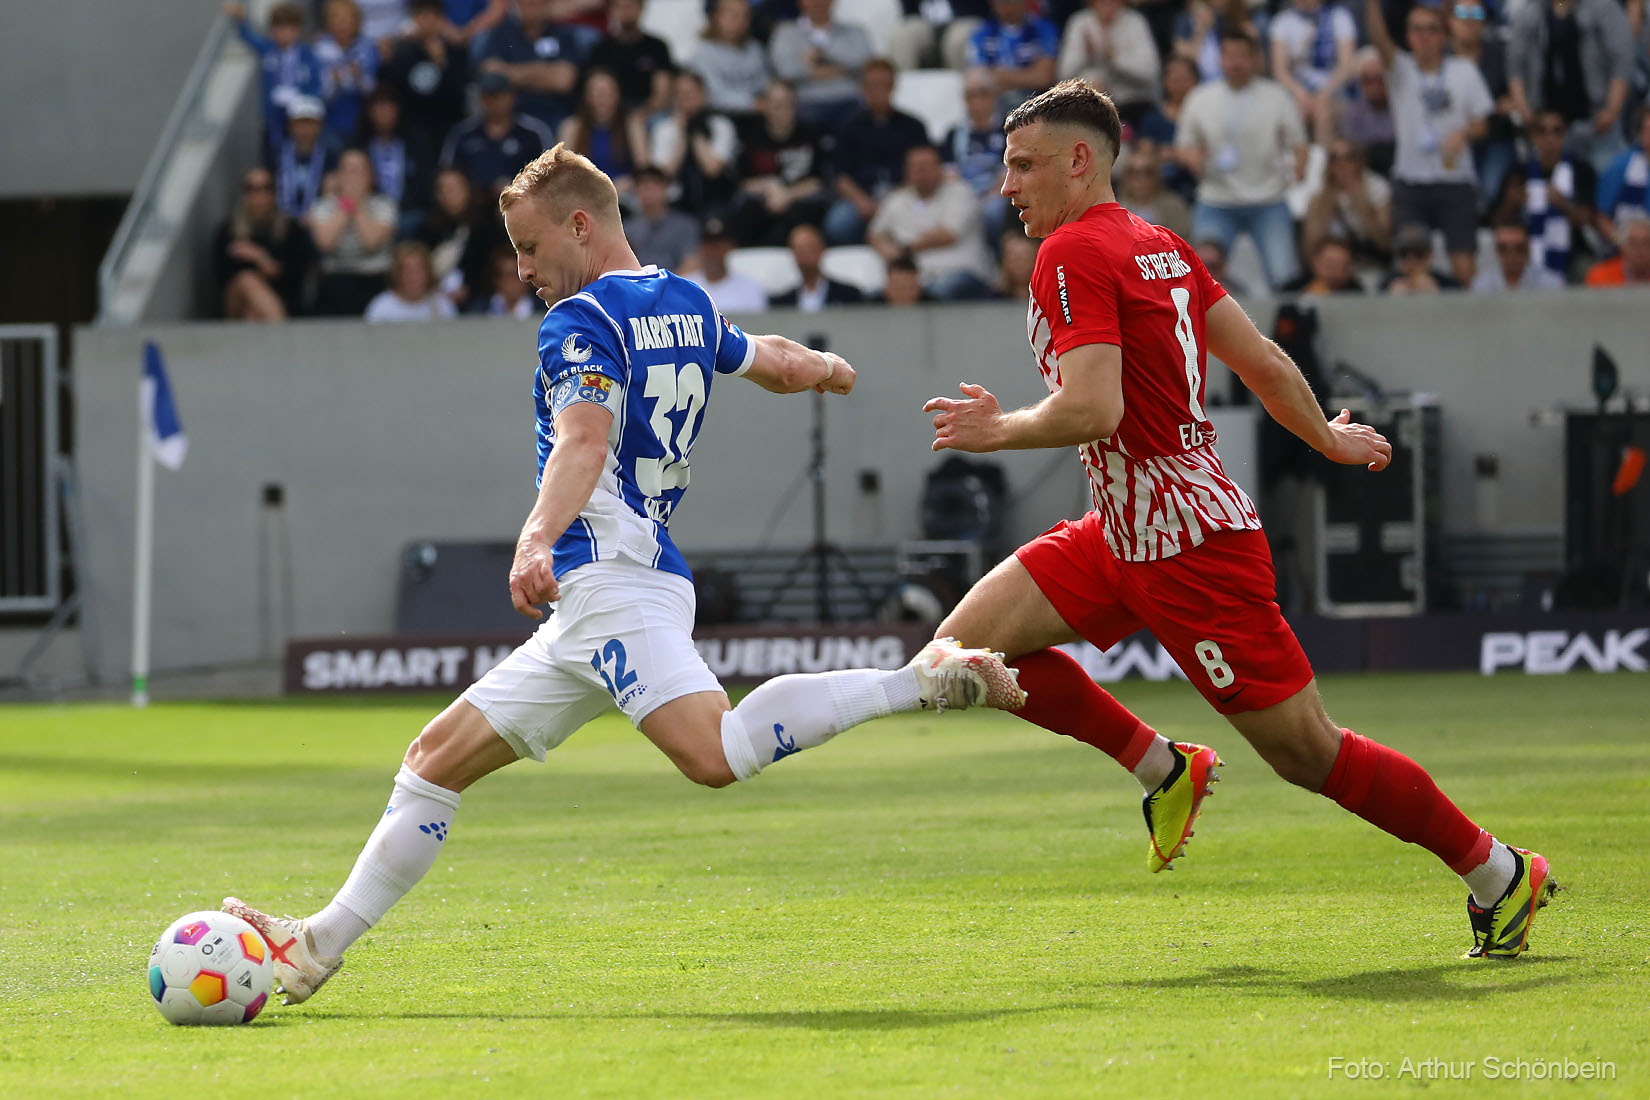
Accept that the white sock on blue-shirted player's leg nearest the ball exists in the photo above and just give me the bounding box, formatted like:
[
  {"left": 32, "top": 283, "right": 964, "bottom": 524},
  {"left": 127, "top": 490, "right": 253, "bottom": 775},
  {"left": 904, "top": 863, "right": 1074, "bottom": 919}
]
[{"left": 309, "top": 764, "right": 459, "bottom": 955}]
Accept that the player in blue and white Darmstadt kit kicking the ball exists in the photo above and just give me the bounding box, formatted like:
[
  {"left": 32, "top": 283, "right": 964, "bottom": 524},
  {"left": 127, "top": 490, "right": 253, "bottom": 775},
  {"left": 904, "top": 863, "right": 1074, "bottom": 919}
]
[{"left": 223, "top": 145, "right": 1025, "bottom": 1004}]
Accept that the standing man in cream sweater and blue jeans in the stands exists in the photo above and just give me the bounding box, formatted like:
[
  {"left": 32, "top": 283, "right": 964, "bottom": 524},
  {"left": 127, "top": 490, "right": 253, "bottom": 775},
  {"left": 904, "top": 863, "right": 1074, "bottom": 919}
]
[{"left": 1175, "top": 30, "right": 1306, "bottom": 295}]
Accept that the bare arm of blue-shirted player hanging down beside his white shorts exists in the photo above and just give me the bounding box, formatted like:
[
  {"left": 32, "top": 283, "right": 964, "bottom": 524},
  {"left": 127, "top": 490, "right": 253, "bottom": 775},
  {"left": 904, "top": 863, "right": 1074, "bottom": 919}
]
[{"left": 510, "top": 401, "right": 614, "bottom": 618}]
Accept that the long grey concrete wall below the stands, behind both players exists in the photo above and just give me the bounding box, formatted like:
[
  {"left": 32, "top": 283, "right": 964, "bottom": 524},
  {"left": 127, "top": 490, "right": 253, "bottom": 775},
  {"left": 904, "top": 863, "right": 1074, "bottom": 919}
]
[{"left": 74, "top": 292, "right": 1650, "bottom": 670}]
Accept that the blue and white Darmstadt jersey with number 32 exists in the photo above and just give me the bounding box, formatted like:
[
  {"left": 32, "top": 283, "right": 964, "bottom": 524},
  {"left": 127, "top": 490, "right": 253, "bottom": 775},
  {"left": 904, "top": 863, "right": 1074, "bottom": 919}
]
[{"left": 533, "top": 267, "right": 756, "bottom": 579}]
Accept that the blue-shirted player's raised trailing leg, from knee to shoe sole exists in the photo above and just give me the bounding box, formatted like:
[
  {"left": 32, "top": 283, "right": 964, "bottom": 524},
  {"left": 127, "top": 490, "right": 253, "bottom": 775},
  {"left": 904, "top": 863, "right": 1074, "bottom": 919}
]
[{"left": 640, "top": 640, "right": 1026, "bottom": 787}]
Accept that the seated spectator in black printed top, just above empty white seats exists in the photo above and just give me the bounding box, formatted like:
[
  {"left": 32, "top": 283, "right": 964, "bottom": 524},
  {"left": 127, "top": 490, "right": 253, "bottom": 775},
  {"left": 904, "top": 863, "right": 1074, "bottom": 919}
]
[{"left": 734, "top": 81, "right": 825, "bottom": 246}]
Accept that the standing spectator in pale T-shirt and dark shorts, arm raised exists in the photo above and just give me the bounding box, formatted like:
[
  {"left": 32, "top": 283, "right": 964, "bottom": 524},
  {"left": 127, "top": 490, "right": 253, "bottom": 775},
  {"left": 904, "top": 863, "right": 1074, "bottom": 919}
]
[{"left": 1365, "top": 0, "right": 1495, "bottom": 285}]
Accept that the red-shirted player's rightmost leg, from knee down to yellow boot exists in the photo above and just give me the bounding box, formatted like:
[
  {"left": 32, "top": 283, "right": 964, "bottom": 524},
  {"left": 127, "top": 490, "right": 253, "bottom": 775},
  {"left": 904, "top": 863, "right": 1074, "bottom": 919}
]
[{"left": 1228, "top": 679, "right": 1558, "bottom": 958}]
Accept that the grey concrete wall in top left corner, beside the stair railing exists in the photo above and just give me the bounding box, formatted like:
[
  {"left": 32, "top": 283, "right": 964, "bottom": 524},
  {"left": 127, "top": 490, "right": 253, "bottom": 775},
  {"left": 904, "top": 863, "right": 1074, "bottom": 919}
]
[{"left": 0, "top": 0, "right": 223, "bottom": 198}]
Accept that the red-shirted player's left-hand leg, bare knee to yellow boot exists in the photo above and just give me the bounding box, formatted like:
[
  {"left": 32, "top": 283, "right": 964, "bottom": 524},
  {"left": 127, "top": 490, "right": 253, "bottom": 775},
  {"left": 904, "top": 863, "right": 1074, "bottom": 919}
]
[{"left": 939, "top": 556, "right": 1221, "bottom": 872}]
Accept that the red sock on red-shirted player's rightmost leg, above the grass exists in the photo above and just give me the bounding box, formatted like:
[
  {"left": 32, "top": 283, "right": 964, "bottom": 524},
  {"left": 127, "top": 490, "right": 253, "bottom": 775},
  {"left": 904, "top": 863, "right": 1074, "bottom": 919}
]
[{"left": 1320, "top": 729, "right": 1493, "bottom": 874}]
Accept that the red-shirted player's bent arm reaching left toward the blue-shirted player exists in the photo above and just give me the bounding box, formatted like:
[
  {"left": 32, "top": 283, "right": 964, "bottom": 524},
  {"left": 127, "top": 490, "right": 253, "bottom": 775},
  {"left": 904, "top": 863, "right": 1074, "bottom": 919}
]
[{"left": 922, "top": 343, "right": 1124, "bottom": 454}]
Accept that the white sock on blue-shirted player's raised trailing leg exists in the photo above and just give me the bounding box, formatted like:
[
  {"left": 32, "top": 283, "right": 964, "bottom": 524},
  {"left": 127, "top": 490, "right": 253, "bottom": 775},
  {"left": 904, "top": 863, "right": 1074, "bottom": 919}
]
[{"left": 723, "top": 668, "right": 922, "bottom": 780}]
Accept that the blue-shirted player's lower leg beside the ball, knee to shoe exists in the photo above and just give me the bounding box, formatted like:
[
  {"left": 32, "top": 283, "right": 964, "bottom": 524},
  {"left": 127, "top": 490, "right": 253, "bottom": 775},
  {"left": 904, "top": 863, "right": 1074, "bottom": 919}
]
[{"left": 223, "top": 699, "right": 516, "bottom": 1004}]
